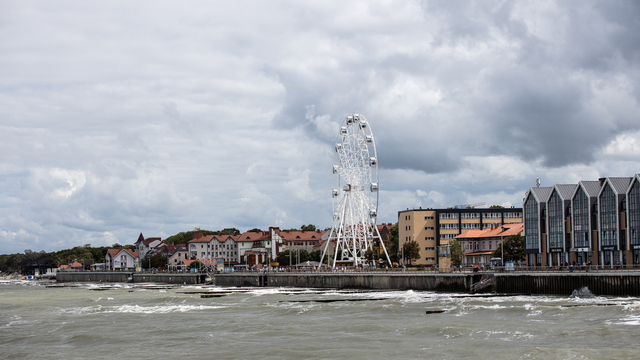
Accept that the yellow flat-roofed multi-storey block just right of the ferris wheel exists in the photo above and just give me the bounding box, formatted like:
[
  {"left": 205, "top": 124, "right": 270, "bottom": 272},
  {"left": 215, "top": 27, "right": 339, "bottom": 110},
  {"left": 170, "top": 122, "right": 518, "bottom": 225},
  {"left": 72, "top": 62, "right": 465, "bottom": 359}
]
[{"left": 398, "top": 207, "right": 522, "bottom": 265}]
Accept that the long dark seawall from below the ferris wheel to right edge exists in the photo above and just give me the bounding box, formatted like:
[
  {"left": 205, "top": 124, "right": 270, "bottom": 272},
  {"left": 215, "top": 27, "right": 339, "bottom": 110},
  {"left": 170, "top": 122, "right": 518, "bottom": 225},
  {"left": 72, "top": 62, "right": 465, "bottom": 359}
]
[{"left": 215, "top": 273, "right": 640, "bottom": 296}]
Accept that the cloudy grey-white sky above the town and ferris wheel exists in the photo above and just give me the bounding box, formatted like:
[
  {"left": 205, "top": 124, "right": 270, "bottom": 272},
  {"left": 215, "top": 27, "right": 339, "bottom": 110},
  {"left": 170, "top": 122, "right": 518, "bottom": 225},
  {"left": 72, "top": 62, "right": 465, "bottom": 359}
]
[{"left": 0, "top": 0, "right": 640, "bottom": 253}]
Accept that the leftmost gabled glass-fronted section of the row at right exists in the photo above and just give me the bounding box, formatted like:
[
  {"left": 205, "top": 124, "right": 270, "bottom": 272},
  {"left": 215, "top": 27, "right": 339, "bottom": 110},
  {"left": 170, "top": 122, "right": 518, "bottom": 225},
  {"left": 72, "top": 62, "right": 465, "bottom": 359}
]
[{"left": 523, "top": 187, "right": 553, "bottom": 265}]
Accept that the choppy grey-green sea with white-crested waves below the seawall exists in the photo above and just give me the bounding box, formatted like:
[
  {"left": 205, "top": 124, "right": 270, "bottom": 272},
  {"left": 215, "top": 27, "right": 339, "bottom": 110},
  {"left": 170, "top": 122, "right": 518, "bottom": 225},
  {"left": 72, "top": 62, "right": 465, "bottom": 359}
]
[{"left": 0, "top": 282, "right": 640, "bottom": 359}]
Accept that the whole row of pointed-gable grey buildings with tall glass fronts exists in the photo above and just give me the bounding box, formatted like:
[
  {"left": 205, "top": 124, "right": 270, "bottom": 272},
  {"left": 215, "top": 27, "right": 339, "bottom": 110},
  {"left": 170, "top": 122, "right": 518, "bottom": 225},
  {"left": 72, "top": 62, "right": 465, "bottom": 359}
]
[{"left": 523, "top": 174, "right": 640, "bottom": 267}]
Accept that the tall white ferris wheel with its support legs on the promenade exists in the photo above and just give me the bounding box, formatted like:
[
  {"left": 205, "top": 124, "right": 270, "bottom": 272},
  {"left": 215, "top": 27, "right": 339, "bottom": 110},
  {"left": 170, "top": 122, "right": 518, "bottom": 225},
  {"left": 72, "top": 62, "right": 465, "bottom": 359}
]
[{"left": 320, "top": 114, "right": 391, "bottom": 266}]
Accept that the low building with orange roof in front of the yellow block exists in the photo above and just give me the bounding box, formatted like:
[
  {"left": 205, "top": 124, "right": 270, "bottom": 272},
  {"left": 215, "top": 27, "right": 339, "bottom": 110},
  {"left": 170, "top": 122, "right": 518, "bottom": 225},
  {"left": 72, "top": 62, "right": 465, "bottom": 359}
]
[{"left": 455, "top": 223, "right": 522, "bottom": 266}]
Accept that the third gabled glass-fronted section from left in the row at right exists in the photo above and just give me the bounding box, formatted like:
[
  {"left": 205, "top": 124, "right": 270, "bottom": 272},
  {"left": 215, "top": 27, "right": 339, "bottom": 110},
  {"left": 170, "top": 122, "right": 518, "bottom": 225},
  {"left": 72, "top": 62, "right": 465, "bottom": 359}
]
[{"left": 571, "top": 181, "right": 601, "bottom": 265}]
